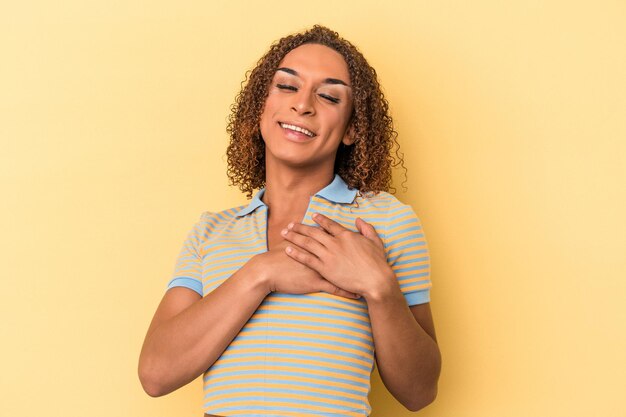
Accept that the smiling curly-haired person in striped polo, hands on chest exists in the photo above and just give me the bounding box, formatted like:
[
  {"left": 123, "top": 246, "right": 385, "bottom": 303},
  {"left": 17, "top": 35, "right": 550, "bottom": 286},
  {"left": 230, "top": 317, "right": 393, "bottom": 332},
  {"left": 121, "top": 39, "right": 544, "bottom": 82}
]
[{"left": 139, "top": 26, "right": 440, "bottom": 416}]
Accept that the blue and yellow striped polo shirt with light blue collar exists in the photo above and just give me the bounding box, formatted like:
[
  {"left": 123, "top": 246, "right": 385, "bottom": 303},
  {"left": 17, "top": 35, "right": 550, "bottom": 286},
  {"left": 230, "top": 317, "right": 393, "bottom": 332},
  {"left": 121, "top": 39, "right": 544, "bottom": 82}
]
[{"left": 168, "top": 175, "right": 431, "bottom": 417}]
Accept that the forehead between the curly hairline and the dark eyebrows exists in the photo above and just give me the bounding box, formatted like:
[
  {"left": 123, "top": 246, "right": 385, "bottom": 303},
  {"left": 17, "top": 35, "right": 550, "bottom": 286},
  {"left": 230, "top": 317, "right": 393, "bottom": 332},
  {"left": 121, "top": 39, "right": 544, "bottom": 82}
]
[{"left": 278, "top": 44, "right": 350, "bottom": 82}]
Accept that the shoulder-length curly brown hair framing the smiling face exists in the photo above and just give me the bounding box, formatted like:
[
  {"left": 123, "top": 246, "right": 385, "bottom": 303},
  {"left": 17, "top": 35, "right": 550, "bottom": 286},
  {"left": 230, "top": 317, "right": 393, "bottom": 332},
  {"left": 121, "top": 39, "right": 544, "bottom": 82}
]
[{"left": 226, "top": 25, "right": 406, "bottom": 198}]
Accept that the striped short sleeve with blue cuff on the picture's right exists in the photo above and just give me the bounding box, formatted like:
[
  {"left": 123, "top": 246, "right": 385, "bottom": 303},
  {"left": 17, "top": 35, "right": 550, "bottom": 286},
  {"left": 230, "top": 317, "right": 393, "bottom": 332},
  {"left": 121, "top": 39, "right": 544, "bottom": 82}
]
[{"left": 384, "top": 201, "right": 432, "bottom": 306}]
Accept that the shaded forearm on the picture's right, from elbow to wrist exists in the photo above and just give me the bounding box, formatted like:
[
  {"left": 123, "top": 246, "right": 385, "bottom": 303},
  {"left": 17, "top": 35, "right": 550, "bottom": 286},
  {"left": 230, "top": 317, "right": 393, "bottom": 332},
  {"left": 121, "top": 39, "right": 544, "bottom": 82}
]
[{"left": 367, "top": 277, "right": 441, "bottom": 411}]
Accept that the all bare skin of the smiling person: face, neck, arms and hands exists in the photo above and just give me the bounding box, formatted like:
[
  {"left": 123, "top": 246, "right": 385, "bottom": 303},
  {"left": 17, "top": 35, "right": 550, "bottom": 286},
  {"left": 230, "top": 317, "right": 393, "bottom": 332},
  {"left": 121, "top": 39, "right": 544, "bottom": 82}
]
[{"left": 139, "top": 44, "right": 440, "bottom": 410}]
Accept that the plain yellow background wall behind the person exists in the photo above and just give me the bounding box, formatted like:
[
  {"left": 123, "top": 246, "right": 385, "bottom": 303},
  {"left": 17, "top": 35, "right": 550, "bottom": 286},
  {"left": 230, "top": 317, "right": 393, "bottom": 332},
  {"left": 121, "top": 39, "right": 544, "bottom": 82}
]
[{"left": 0, "top": 0, "right": 626, "bottom": 417}]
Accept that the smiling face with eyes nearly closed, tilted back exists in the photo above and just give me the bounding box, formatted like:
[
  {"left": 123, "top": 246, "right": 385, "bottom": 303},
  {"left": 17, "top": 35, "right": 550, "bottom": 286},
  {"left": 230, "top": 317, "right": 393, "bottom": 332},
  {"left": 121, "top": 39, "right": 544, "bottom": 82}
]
[{"left": 260, "top": 44, "right": 353, "bottom": 171}]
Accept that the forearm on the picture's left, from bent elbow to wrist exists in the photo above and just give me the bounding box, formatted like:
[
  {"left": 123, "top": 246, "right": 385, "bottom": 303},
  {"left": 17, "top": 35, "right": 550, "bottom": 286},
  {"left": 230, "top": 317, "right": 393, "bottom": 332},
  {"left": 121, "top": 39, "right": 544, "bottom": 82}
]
[{"left": 139, "top": 267, "right": 268, "bottom": 396}]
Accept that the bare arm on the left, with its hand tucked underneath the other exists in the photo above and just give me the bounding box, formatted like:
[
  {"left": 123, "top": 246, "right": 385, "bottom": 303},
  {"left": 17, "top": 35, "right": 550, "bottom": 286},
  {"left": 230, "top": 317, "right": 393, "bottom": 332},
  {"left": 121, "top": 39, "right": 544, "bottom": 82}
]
[{"left": 139, "top": 247, "right": 355, "bottom": 396}]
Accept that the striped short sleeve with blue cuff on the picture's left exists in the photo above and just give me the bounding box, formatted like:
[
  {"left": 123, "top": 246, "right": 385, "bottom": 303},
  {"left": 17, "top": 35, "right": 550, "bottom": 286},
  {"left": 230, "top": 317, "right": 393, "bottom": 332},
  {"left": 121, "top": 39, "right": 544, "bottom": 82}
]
[{"left": 167, "top": 212, "right": 210, "bottom": 296}]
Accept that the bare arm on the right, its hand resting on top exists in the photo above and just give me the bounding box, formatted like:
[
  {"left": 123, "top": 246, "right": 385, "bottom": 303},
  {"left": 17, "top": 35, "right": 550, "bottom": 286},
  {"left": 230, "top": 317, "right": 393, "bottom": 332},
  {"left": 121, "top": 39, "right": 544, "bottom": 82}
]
[{"left": 284, "top": 214, "right": 441, "bottom": 411}]
